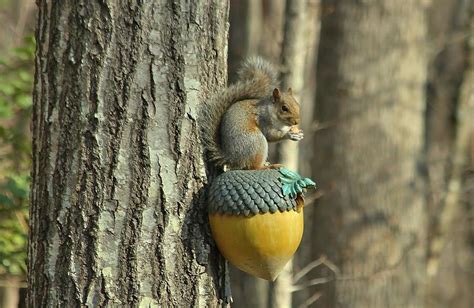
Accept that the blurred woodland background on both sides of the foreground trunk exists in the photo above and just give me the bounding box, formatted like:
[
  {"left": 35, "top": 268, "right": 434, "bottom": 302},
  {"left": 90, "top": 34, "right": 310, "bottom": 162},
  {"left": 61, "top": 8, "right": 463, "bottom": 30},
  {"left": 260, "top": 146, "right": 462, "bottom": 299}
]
[{"left": 0, "top": 0, "right": 474, "bottom": 308}]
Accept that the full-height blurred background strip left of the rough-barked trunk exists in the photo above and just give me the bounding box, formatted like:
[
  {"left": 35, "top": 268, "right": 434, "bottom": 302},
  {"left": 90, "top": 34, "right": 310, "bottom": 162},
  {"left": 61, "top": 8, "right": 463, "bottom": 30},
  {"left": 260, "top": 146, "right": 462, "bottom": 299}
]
[{"left": 0, "top": 0, "right": 36, "bottom": 308}]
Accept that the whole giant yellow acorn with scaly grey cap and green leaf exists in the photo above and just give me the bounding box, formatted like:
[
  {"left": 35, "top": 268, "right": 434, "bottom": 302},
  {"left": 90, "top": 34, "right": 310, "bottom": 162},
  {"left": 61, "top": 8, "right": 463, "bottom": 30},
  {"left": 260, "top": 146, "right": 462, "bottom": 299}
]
[{"left": 207, "top": 168, "right": 316, "bottom": 280}]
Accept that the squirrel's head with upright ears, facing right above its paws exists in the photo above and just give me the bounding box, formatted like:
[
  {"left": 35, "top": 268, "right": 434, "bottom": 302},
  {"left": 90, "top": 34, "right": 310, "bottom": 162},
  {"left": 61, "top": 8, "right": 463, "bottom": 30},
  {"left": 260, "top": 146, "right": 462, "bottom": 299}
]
[{"left": 272, "top": 88, "right": 300, "bottom": 126}]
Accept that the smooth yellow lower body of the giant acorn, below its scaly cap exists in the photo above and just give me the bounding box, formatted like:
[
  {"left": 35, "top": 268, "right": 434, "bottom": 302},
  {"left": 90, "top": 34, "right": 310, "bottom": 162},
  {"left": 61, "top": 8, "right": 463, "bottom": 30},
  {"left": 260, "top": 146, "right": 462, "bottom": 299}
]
[{"left": 209, "top": 206, "right": 304, "bottom": 281}]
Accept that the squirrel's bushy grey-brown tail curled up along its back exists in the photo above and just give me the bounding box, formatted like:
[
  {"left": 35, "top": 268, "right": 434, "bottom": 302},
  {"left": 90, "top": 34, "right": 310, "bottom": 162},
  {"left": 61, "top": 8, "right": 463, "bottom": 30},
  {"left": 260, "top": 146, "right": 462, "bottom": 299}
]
[{"left": 199, "top": 57, "right": 278, "bottom": 166}]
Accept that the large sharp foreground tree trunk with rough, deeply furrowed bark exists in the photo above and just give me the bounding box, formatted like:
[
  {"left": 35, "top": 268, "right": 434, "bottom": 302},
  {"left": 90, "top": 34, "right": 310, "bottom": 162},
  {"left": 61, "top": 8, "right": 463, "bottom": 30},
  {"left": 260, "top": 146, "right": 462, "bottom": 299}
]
[{"left": 28, "top": 0, "right": 228, "bottom": 307}]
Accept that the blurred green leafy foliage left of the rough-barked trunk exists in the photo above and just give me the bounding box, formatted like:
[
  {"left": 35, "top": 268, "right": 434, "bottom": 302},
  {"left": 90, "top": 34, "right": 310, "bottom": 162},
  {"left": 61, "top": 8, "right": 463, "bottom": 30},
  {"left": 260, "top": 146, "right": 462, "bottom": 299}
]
[{"left": 0, "top": 37, "right": 35, "bottom": 275}]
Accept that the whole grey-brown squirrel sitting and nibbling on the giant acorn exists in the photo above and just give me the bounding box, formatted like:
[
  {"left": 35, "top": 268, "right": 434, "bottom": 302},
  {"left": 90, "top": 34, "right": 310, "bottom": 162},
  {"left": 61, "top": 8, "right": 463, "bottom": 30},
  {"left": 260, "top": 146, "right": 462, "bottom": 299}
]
[{"left": 200, "top": 57, "right": 303, "bottom": 169}]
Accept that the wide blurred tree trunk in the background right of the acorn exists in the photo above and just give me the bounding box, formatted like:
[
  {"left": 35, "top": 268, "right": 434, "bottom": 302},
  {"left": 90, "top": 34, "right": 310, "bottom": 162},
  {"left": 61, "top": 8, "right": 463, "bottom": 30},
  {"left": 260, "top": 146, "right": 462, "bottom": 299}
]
[{"left": 312, "top": 0, "right": 426, "bottom": 307}]
